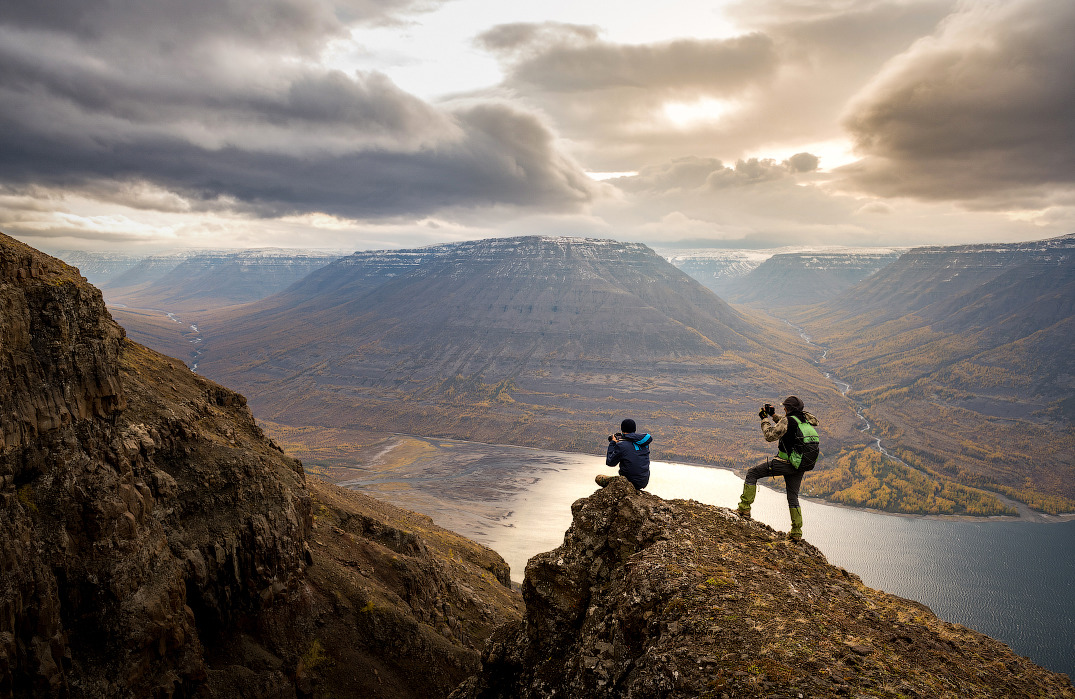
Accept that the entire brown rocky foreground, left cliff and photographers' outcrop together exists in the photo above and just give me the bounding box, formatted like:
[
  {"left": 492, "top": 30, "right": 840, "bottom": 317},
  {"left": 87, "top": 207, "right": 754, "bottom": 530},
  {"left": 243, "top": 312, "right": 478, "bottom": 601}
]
[{"left": 0, "top": 234, "right": 1075, "bottom": 699}]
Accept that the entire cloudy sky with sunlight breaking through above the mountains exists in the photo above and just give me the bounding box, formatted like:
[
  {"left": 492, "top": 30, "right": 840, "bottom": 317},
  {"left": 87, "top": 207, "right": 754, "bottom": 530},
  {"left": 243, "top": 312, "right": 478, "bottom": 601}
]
[{"left": 0, "top": 0, "right": 1075, "bottom": 254}]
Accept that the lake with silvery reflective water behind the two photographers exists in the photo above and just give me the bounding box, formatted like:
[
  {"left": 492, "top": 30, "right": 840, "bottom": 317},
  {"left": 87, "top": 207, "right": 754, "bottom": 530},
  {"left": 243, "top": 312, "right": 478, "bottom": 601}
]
[{"left": 341, "top": 438, "right": 1075, "bottom": 676}]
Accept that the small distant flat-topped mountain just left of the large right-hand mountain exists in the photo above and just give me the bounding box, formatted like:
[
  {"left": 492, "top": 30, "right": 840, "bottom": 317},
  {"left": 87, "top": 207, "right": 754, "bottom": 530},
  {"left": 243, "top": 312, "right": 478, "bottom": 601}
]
[{"left": 725, "top": 248, "right": 903, "bottom": 310}]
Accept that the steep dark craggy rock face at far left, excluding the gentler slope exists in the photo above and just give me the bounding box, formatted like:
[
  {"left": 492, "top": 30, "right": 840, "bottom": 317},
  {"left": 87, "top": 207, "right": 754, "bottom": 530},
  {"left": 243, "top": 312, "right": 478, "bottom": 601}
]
[{"left": 0, "top": 232, "right": 311, "bottom": 696}]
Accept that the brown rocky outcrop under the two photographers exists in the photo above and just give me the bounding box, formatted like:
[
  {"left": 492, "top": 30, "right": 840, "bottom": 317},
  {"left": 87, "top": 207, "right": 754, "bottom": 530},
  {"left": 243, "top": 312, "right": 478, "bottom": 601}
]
[{"left": 452, "top": 477, "right": 1075, "bottom": 699}]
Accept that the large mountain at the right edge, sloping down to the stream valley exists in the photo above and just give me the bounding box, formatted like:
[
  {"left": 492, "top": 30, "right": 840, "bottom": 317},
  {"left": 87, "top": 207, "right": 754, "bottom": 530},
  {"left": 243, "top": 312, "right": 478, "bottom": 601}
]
[{"left": 793, "top": 236, "right": 1075, "bottom": 505}]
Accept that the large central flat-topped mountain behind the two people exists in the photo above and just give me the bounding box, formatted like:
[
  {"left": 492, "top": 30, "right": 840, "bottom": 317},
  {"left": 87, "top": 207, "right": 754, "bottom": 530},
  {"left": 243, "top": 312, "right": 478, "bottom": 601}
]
[{"left": 199, "top": 237, "right": 860, "bottom": 466}]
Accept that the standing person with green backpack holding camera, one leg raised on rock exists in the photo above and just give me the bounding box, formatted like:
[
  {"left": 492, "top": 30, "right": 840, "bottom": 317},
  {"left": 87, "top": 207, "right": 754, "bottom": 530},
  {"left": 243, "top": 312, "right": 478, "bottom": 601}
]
[{"left": 736, "top": 396, "right": 818, "bottom": 540}]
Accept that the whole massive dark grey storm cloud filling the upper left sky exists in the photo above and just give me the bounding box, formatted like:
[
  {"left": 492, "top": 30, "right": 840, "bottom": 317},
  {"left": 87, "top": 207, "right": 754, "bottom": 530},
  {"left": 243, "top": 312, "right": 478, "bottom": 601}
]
[{"left": 0, "top": 0, "right": 593, "bottom": 218}]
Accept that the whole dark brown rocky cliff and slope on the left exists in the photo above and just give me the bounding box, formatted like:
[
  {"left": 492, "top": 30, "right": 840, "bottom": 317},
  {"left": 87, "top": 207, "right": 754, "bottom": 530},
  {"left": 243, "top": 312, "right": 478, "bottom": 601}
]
[{"left": 0, "top": 234, "right": 518, "bottom": 697}]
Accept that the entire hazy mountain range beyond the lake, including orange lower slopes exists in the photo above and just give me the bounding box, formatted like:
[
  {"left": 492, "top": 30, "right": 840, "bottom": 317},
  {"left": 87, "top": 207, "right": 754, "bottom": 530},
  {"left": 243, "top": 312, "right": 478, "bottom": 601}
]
[{"left": 96, "top": 232, "right": 1075, "bottom": 514}]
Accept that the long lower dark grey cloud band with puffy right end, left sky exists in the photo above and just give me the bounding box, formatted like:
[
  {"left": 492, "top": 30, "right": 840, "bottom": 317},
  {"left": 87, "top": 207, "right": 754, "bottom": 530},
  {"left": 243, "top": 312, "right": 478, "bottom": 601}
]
[{"left": 0, "top": 99, "right": 592, "bottom": 217}]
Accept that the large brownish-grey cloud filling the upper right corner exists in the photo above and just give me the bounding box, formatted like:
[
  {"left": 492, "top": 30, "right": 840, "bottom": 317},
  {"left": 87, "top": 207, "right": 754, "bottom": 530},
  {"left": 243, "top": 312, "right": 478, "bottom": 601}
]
[{"left": 843, "top": 0, "right": 1075, "bottom": 209}]
